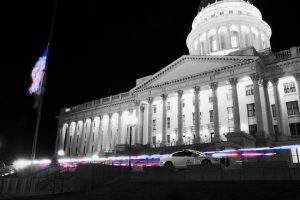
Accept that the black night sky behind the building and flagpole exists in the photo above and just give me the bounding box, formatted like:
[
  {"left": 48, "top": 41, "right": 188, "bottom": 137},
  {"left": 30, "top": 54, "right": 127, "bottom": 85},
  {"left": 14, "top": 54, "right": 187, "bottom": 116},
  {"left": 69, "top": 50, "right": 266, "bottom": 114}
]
[{"left": 0, "top": 0, "right": 300, "bottom": 162}]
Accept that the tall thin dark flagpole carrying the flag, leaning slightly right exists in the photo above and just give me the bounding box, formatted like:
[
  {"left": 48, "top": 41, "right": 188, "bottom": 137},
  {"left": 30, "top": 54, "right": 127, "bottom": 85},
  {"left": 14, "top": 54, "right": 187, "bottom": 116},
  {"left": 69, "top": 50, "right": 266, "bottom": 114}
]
[{"left": 31, "top": 0, "right": 58, "bottom": 161}]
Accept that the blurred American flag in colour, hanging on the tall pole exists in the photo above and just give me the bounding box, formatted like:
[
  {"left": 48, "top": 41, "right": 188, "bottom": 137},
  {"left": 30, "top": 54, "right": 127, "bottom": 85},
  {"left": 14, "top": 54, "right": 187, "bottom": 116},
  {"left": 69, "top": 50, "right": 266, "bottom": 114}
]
[{"left": 28, "top": 48, "right": 48, "bottom": 95}]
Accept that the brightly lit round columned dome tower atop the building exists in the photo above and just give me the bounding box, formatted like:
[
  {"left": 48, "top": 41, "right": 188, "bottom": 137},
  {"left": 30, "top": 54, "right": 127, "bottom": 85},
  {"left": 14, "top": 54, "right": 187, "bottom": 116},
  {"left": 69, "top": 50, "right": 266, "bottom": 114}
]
[{"left": 187, "top": 0, "right": 272, "bottom": 55}]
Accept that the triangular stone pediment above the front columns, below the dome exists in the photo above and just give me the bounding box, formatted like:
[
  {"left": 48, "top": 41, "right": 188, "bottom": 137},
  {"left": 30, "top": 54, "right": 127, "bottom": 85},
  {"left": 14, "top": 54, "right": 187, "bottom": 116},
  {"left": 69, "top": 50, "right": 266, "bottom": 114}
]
[{"left": 133, "top": 56, "right": 257, "bottom": 91}]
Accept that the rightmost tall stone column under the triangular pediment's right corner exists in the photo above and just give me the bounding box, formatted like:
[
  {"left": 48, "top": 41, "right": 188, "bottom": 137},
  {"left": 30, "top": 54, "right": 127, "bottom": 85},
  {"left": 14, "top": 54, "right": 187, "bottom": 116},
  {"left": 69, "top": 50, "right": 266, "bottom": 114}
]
[{"left": 250, "top": 74, "right": 266, "bottom": 146}]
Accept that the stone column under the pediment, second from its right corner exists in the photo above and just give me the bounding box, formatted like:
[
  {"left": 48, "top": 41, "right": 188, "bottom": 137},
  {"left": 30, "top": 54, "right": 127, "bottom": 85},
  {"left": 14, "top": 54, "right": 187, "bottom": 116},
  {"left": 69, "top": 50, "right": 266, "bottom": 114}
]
[{"left": 229, "top": 78, "right": 241, "bottom": 133}]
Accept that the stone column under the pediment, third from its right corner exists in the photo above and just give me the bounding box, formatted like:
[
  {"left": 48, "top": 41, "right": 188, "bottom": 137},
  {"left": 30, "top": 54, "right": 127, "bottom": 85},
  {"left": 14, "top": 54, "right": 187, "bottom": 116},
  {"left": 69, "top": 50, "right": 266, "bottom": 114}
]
[{"left": 209, "top": 82, "right": 220, "bottom": 142}]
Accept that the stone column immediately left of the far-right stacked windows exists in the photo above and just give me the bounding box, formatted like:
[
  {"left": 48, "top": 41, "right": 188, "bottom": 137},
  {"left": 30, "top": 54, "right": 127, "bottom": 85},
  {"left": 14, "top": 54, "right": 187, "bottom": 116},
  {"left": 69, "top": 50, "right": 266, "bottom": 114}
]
[{"left": 272, "top": 78, "right": 285, "bottom": 141}]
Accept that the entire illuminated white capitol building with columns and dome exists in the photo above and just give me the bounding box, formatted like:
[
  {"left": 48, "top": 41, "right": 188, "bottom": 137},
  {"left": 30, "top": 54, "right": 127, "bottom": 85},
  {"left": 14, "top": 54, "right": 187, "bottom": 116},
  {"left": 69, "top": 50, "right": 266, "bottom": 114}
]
[{"left": 55, "top": 0, "right": 300, "bottom": 157}]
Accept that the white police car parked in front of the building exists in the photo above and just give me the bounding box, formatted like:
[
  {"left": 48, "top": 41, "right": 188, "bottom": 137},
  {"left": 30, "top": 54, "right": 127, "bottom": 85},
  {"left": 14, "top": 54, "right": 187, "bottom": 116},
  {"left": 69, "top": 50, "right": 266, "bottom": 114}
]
[{"left": 159, "top": 149, "right": 221, "bottom": 168}]
